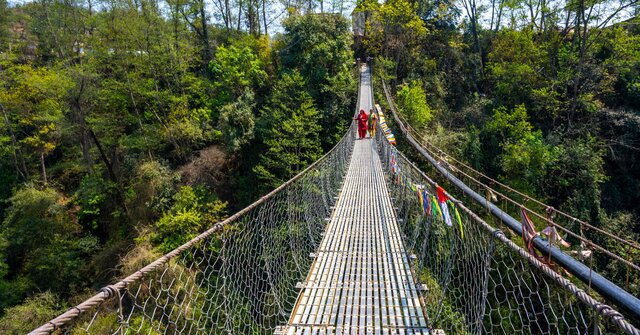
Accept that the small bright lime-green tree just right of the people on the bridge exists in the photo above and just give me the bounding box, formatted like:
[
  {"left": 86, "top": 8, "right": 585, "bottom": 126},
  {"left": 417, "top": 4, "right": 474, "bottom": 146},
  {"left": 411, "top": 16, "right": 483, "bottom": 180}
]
[{"left": 398, "top": 81, "right": 433, "bottom": 129}]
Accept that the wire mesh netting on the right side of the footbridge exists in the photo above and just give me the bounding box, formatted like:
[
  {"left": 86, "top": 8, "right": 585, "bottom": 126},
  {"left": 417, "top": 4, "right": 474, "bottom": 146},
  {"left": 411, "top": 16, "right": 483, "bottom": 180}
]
[{"left": 376, "top": 129, "right": 638, "bottom": 334}]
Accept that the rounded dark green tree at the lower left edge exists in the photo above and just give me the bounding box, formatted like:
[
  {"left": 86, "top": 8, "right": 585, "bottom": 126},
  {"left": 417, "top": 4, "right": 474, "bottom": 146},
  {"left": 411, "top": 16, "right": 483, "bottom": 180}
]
[{"left": 0, "top": 186, "right": 98, "bottom": 302}]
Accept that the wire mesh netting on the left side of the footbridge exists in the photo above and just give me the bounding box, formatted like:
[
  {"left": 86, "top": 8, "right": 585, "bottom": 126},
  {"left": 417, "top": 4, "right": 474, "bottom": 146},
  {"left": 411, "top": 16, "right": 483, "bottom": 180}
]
[{"left": 34, "top": 127, "right": 354, "bottom": 334}]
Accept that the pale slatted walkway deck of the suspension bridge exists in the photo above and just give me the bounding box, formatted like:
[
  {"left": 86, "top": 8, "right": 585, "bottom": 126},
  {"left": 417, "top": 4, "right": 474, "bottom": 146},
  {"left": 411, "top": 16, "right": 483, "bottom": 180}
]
[{"left": 276, "top": 65, "right": 429, "bottom": 335}]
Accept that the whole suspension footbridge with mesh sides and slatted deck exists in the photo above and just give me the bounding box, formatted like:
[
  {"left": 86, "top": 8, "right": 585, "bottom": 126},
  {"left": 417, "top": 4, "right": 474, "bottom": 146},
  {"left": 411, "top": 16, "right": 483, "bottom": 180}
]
[{"left": 32, "top": 66, "right": 640, "bottom": 335}]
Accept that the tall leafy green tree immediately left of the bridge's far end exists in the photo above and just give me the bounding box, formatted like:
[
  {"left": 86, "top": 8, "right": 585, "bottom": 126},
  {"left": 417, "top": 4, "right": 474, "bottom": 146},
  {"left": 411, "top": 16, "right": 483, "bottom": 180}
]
[{"left": 276, "top": 14, "right": 357, "bottom": 148}]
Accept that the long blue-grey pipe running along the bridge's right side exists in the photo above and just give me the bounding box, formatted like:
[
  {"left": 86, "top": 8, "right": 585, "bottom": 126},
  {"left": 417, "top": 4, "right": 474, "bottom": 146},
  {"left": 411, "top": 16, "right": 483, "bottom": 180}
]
[{"left": 382, "top": 77, "right": 639, "bottom": 326}]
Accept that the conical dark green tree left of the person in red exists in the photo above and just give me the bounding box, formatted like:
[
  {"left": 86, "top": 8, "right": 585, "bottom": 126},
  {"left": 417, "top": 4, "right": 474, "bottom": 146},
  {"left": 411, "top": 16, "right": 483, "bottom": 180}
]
[{"left": 253, "top": 72, "right": 322, "bottom": 188}]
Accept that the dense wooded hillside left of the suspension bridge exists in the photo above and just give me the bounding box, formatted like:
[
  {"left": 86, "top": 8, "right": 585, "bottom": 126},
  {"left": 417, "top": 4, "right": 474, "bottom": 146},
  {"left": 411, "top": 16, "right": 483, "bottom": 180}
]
[{"left": 0, "top": 0, "right": 357, "bottom": 333}]
